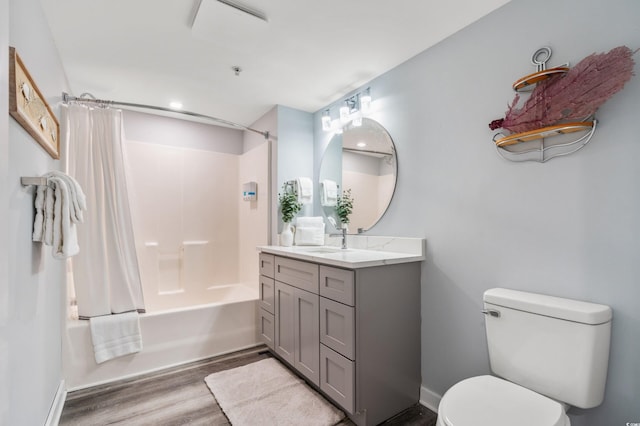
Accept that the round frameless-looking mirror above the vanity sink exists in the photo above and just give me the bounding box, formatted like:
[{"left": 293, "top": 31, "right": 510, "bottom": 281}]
[{"left": 319, "top": 118, "right": 398, "bottom": 234}]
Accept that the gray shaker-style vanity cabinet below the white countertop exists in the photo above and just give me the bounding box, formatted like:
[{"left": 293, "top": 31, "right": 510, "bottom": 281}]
[{"left": 260, "top": 253, "right": 421, "bottom": 426}]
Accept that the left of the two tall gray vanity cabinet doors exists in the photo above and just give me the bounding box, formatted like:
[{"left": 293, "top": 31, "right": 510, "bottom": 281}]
[{"left": 274, "top": 281, "right": 295, "bottom": 365}]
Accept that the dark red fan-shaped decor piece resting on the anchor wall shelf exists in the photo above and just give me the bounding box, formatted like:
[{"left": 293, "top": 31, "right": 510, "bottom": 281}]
[{"left": 489, "top": 46, "right": 637, "bottom": 133}]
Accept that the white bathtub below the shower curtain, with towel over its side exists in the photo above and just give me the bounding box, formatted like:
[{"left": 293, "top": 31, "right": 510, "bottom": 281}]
[{"left": 62, "top": 284, "right": 260, "bottom": 391}]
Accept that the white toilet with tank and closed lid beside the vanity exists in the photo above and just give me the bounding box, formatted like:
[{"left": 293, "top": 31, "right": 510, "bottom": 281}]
[{"left": 437, "top": 288, "right": 612, "bottom": 426}]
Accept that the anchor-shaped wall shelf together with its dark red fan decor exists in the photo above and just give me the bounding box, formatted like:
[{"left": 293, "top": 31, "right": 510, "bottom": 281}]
[{"left": 489, "top": 46, "right": 635, "bottom": 162}]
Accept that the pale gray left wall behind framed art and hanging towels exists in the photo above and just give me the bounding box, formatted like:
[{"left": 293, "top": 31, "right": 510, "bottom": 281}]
[{"left": 0, "top": 0, "right": 68, "bottom": 425}]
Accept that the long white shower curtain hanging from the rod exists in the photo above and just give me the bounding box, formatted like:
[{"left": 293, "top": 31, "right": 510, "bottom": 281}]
[{"left": 62, "top": 104, "right": 144, "bottom": 318}]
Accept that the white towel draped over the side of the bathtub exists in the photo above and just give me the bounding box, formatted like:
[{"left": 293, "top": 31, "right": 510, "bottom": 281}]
[{"left": 89, "top": 311, "right": 142, "bottom": 364}]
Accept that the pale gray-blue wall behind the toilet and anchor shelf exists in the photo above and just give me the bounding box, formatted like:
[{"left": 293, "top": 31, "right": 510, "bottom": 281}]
[{"left": 314, "top": 0, "right": 640, "bottom": 426}]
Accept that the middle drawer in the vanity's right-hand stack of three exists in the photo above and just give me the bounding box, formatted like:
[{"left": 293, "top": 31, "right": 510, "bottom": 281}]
[{"left": 320, "top": 297, "right": 355, "bottom": 359}]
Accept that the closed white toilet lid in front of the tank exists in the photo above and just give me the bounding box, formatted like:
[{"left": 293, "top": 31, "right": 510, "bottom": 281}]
[{"left": 438, "top": 376, "right": 570, "bottom": 426}]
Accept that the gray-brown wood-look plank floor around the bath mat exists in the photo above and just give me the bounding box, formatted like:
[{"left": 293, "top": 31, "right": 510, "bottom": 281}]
[{"left": 60, "top": 347, "right": 436, "bottom": 426}]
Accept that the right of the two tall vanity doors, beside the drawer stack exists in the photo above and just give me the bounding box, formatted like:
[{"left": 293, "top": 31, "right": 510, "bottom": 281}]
[{"left": 293, "top": 288, "right": 320, "bottom": 385}]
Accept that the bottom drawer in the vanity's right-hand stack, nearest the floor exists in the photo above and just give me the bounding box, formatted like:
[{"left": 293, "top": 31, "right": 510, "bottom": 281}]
[{"left": 320, "top": 345, "right": 355, "bottom": 414}]
